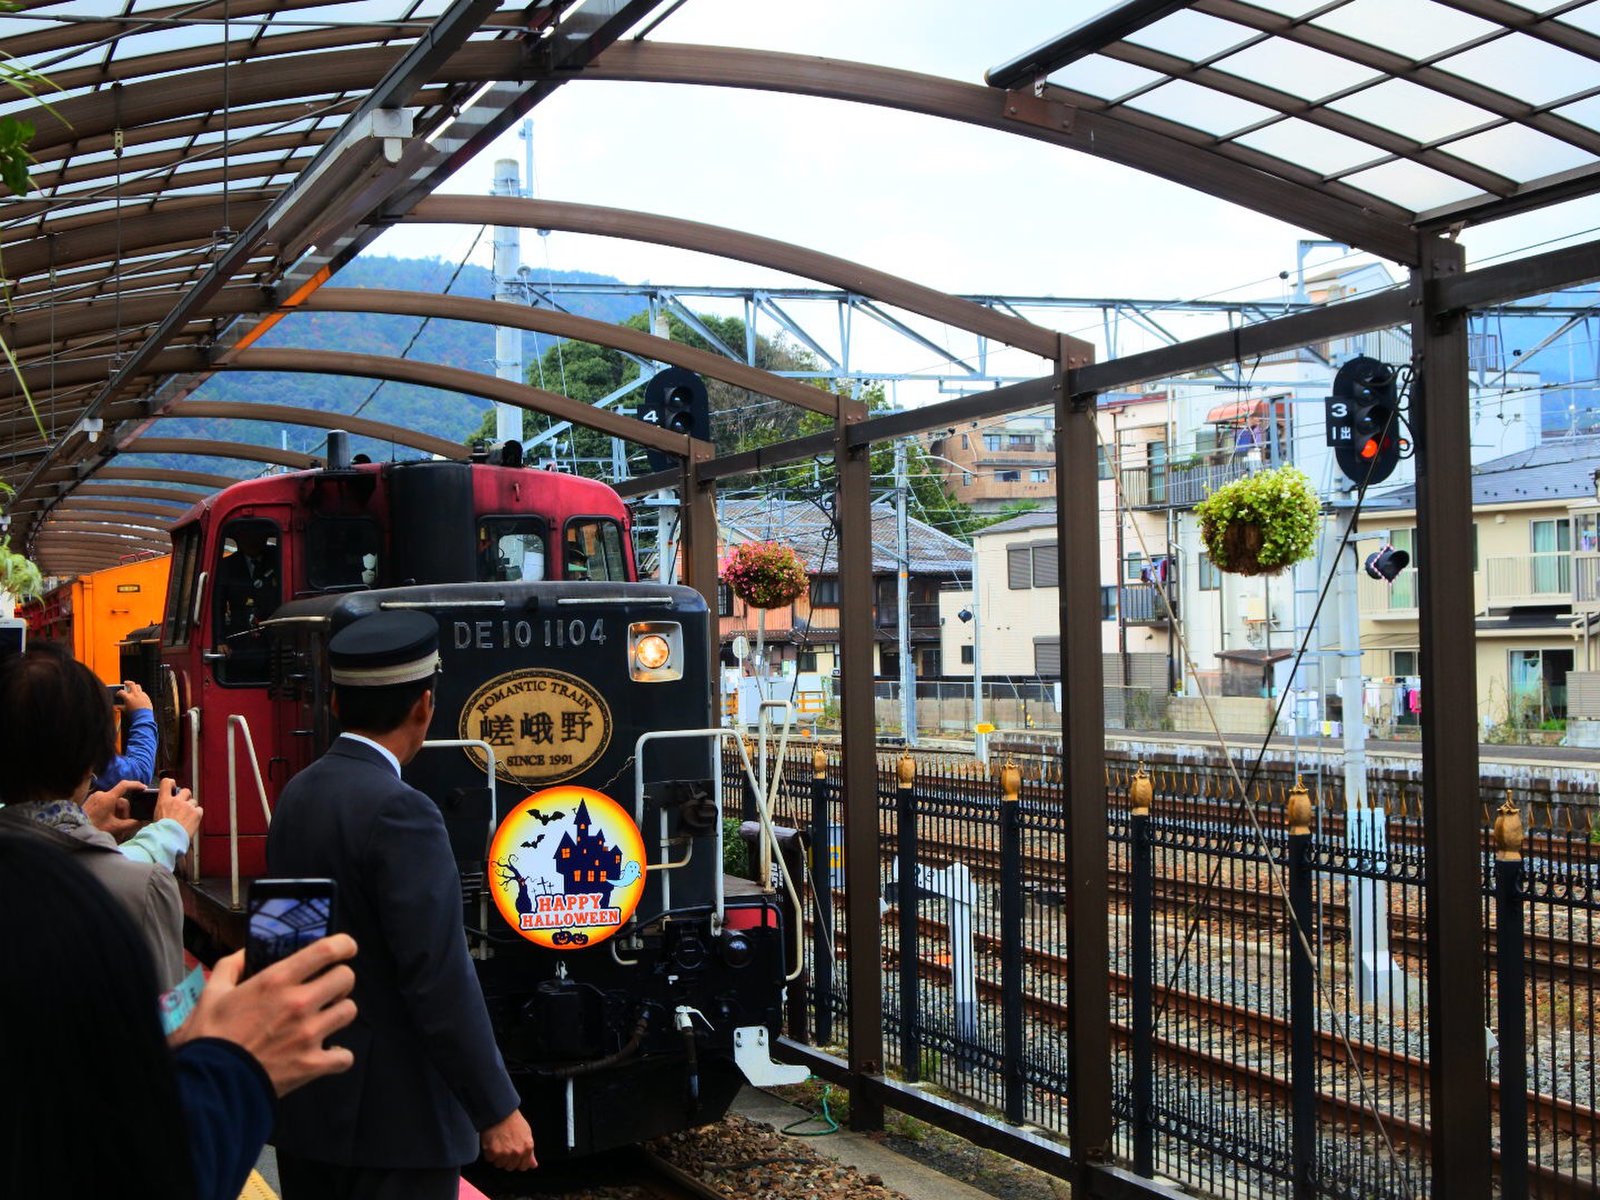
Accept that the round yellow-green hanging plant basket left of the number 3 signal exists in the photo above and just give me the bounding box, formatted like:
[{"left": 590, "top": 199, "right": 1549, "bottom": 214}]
[{"left": 1195, "top": 467, "right": 1322, "bottom": 574}]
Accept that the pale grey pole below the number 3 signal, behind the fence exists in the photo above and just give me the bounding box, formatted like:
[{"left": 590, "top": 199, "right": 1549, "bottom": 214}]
[{"left": 1334, "top": 501, "right": 1408, "bottom": 1008}]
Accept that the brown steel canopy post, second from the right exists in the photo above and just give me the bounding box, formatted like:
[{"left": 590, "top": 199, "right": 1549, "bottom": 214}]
[{"left": 1056, "top": 338, "right": 1112, "bottom": 1195}]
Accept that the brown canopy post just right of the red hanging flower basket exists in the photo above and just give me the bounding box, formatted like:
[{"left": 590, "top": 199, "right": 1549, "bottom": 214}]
[{"left": 834, "top": 416, "right": 883, "bottom": 1130}]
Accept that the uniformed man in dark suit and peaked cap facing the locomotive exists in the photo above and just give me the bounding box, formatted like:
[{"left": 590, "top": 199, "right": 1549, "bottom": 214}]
[{"left": 267, "top": 610, "right": 536, "bottom": 1200}]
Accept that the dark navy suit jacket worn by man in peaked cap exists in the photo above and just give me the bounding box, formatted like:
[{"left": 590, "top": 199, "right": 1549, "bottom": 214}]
[{"left": 267, "top": 738, "right": 518, "bottom": 1168}]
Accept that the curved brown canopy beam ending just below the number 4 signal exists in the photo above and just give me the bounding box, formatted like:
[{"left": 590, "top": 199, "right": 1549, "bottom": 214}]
[{"left": 214, "top": 347, "right": 710, "bottom": 458}]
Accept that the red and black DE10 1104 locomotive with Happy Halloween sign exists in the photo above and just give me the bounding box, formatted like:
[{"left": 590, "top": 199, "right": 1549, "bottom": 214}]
[{"left": 144, "top": 448, "right": 805, "bottom": 1160}]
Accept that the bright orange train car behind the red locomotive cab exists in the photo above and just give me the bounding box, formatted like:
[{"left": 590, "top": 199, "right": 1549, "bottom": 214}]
[{"left": 21, "top": 555, "right": 171, "bottom": 683}]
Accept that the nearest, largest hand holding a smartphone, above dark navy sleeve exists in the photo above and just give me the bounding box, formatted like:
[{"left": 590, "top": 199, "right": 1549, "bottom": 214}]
[{"left": 171, "top": 933, "right": 361, "bottom": 1100}]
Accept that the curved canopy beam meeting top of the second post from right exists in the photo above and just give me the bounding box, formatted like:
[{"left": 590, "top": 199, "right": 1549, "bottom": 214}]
[{"left": 400, "top": 195, "right": 1068, "bottom": 358}]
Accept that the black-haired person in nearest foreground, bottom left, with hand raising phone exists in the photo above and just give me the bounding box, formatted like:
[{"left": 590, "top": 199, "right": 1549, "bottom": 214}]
[{"left": 0, "top": 834, "right": 355, "bottom": 1200}]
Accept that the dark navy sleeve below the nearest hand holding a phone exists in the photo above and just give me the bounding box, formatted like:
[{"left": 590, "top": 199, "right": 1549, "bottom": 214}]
[{"left": 173, "top": 1037, "right": 277, "bottom": 1200}]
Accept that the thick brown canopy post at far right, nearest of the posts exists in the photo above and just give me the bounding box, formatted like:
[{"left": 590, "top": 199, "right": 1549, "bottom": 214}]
[{"left": 1411, "top": 237, "right": 1491, "bottom": 1200}]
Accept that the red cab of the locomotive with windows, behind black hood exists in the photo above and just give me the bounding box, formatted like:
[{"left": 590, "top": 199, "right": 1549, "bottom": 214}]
[{"left": 157, "top": 461, "right": 637, "bottom": 909}]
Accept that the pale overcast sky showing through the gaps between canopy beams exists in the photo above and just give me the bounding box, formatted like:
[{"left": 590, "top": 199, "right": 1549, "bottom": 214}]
[{"left": 374, "top": 0, "right": 1600, "bottom": 376}]
